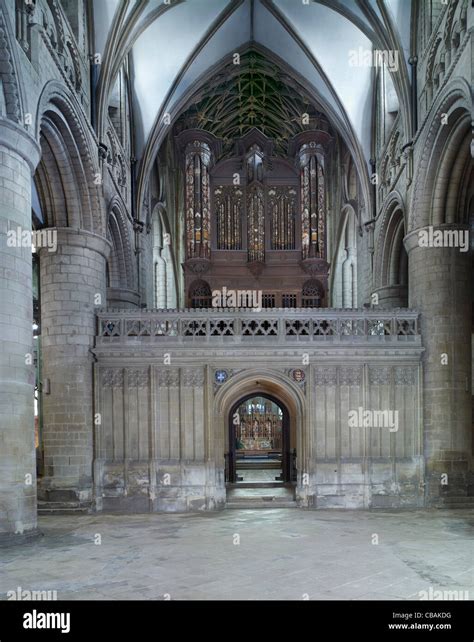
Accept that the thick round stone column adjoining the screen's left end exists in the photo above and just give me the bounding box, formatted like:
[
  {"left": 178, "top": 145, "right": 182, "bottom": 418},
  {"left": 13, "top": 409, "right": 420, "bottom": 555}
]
[{"left": 38, "top": 228, "right": 110, "bottom": 508}]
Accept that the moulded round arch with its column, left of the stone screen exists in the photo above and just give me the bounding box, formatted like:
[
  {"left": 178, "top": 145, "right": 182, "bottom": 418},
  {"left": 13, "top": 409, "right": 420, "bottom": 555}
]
[{"left": 35, "top": 80, "right": 109, "bottom": 506}]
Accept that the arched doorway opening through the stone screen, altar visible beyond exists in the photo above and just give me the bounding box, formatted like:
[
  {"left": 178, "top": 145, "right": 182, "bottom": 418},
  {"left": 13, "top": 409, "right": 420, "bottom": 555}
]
[{"left": 226, "top": 393, "right": 294, "bottom": 485}]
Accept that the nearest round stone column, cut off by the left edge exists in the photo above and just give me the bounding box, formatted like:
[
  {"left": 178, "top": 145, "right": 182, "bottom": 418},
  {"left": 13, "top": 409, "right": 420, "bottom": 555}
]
[{"left": 0, "top": 118, "right": 41, "bottom": 543}]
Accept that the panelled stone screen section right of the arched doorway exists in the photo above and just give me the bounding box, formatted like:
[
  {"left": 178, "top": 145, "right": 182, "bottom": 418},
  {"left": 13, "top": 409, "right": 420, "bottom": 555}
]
[{"left": 308, "top": 358, "right": 424, "bottom": 508}]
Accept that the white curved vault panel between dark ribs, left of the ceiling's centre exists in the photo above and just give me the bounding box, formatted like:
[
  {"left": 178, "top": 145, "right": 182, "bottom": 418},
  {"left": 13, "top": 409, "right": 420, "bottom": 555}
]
[{"left": 132, "top": 0, "right": 228, "bottom": 153}]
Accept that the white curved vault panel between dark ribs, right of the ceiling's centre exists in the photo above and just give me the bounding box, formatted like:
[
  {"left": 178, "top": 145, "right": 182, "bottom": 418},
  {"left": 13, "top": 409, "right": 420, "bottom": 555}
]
[{"left": 275, "top": 0, "right": 373, "bottom": 158}]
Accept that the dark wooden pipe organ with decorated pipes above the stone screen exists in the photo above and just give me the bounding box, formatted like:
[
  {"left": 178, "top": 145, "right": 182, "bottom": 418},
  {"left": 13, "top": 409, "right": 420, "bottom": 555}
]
[{"left": 177, "top": 129, "right": 332, "bottom": 307}]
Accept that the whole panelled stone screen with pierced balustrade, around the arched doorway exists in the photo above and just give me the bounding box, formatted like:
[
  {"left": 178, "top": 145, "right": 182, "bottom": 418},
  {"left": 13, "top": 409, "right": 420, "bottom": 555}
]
[{"left": 94, "top": 310, "right": 424, "bottom": 512}]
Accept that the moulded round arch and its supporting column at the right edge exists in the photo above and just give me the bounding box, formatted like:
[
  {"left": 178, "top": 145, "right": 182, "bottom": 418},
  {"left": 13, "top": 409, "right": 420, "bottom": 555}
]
[{"left": 404, "top": 79, "right": 473, "bottom": 505}]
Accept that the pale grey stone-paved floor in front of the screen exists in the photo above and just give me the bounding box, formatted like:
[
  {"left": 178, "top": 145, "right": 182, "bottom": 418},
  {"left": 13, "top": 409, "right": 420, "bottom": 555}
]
[{"left": 0, "top": 509, "right": 474, "bottom": 600}]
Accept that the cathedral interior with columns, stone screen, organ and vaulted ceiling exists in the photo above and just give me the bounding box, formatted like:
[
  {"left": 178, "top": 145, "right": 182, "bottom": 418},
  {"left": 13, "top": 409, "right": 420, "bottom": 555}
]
[{"left": 0, "top": 0, "right": 474, "bottom": 599}]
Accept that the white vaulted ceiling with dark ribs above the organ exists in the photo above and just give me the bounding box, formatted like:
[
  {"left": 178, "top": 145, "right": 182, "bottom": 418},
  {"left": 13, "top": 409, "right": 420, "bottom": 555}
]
[{"left": 94, "top": 0, "right": 411, "bottom": 205}]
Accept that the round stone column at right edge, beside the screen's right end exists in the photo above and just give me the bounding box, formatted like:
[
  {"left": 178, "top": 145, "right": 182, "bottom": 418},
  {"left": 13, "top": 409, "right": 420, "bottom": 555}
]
[{"left": 404, "top": 225, "right": 472, "bottom": 503}]
